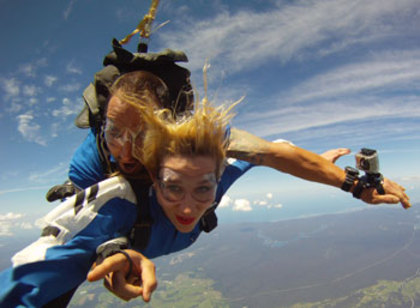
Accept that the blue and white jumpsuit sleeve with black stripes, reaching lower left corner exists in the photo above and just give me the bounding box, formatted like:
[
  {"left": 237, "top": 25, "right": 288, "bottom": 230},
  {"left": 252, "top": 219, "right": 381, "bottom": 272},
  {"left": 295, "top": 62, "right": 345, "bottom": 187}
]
[{"left": 0, "top": 177, "right": 137, "bottom": 307}]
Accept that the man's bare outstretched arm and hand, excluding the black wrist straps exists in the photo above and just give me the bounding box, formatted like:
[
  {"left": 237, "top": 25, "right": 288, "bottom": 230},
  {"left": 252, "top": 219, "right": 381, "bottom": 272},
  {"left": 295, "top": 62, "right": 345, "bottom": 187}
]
[{"left": 227, "top": 128, "right": 411, "bottom": 208}]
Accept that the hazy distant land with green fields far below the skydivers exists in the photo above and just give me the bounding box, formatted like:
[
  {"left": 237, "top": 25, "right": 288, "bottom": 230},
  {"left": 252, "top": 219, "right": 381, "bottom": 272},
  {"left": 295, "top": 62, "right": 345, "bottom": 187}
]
[{"left": 64, "top": 205, "right": 420, "bottom": 308}]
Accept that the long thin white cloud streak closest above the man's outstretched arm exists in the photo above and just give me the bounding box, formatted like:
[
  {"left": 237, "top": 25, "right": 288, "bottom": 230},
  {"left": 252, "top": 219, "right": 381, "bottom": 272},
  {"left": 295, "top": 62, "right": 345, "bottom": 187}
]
[{"left": 235, "top": 95, "right": 420, "bottom": 136}]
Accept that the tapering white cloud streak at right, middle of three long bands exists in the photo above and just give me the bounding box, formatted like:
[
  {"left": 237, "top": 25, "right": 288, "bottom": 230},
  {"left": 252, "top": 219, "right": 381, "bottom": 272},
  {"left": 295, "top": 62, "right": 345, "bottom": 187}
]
[{"left": 285, "top": 50, "right": 420, "bottom": 103}]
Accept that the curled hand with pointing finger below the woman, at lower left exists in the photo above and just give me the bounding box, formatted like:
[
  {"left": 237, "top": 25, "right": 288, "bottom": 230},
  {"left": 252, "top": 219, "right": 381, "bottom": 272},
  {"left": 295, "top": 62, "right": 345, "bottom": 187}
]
[{"left": 87, "top": 249, "right": 157, "bottom": 302}]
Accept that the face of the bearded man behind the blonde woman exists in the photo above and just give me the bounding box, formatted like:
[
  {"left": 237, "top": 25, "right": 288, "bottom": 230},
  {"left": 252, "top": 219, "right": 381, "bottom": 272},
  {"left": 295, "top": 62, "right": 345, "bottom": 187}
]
[{"left": 105, "top": 96, "right": 144, "bottom": 176}]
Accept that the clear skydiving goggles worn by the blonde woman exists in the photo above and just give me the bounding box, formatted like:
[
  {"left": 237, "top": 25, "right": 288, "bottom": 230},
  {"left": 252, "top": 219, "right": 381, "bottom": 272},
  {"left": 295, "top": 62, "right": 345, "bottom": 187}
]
[{"left": 157, "top": 168, "right": 217, "bottom": 202}]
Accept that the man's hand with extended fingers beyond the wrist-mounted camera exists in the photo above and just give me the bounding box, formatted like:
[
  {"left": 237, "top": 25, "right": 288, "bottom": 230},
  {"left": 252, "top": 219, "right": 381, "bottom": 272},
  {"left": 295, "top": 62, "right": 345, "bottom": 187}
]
[{"left": 360, "top": 178, "right": 411, "bottom": 209}]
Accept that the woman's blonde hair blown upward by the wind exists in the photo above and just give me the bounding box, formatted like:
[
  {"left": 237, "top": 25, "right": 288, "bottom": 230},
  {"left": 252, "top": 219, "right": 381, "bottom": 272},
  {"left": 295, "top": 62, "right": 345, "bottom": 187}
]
[{"left": 138, "top": 71, "right": 241, "bottom": 179}]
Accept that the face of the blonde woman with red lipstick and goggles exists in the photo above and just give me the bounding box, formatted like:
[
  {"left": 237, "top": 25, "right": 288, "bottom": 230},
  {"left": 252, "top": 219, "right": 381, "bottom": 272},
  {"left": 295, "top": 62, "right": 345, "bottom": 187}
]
[{"left": 153, "top": 156, "right": 217, "bottom": 233}]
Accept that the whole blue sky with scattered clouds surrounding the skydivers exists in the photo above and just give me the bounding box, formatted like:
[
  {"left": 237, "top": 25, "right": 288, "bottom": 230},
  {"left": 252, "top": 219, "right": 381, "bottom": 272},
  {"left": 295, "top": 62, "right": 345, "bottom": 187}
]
[{"left": 0, "top": 0, "right": 420, "bottom": 236}]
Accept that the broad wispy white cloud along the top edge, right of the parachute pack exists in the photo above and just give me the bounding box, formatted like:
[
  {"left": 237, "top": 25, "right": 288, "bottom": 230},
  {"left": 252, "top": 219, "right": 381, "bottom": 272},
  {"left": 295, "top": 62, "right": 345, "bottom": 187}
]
[{"left": 160, "top": 0, "right": 420, "bottom": 73}]
